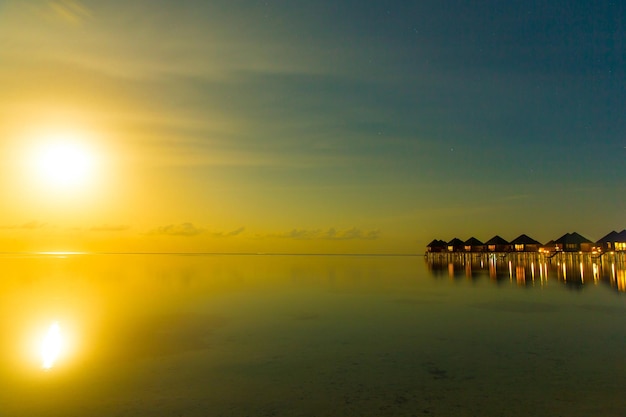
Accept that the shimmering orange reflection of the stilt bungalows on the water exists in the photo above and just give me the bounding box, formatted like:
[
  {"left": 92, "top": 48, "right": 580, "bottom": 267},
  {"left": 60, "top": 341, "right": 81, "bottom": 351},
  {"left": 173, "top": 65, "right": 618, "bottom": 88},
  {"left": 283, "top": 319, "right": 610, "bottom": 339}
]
[{"left": 425, "top": 253, "right": 626, "bottom": 292}]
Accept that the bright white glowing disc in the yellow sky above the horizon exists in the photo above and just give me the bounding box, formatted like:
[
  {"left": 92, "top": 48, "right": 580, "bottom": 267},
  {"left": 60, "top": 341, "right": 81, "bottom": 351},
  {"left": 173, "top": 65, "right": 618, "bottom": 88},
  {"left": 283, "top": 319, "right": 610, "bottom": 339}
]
[{"left": 32, "top": 135, "right": 95, "bottom": 189}]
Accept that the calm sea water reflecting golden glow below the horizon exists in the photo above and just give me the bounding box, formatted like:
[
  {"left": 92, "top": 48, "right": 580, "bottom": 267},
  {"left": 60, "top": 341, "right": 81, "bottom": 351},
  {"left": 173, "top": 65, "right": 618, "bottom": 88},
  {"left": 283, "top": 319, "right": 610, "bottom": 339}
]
[{"left": 0, "top": 255, "right": 626, "bottom": 417}]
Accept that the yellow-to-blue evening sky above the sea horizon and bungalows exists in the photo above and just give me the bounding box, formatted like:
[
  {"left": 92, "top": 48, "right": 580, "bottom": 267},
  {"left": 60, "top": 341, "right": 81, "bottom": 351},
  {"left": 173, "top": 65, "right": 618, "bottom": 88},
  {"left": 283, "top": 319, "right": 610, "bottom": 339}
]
[{"left": 0, "top": 0, "right": 626, "bottom": 254}]
